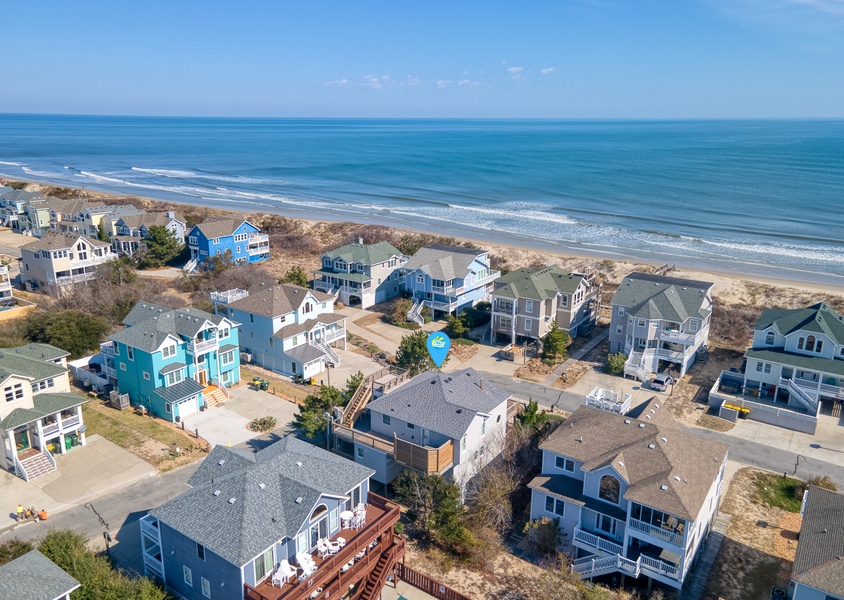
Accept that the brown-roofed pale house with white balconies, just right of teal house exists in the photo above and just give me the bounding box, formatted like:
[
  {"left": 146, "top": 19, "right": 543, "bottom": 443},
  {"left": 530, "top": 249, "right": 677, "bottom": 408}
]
[{"left": 211, "top": 283, "right": 346, "bottom": 379}]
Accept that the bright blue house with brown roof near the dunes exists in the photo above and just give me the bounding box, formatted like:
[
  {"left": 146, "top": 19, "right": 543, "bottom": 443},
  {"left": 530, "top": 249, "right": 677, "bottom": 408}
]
[{"left": 187, "top": 218, "right": 270, "bottom": 270}]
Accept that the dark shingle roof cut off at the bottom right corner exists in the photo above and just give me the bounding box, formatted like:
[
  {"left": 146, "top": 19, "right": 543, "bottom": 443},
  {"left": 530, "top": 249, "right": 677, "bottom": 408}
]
[{"left": 791, "top": 486, "right": 844, "bottom": 596}]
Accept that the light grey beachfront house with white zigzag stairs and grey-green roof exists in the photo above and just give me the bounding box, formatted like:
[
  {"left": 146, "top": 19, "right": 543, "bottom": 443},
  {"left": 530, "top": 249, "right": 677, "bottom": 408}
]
[{"left": 609, "top": 273, "right": 714, "bottom": 381}]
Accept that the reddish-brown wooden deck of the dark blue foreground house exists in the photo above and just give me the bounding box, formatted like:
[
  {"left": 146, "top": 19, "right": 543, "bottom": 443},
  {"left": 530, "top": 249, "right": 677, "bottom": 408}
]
[{"left": 243, "top": 493, "right": 404, "bottom": 600}]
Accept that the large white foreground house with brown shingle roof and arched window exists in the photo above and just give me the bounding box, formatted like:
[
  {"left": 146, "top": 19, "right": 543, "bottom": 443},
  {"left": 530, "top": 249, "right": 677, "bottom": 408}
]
[{"left": 530, "top": 399, "right": 727, "bottom": 589}]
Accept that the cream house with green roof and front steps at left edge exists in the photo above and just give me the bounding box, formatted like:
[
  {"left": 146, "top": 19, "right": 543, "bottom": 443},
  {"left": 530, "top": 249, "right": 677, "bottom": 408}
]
[{"left": 0, "top": 344, "right": 86, "bottom": 481}]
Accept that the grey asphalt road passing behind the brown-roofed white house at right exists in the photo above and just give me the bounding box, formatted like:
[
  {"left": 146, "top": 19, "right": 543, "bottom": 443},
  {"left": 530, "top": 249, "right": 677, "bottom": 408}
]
[{"left": 483, "top": 372, "right": 844, "bottom": 489}]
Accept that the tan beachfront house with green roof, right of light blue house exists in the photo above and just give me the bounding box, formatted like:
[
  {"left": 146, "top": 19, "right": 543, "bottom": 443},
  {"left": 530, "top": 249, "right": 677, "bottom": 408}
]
[{"left": 492, "top": 267, "right": 601, "bottom": 344}]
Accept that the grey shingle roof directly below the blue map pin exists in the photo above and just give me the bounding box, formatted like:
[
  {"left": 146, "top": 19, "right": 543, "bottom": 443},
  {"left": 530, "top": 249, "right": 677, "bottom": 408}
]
[{"left": 368, "top": 368, "right": 510, "bottom": 440}]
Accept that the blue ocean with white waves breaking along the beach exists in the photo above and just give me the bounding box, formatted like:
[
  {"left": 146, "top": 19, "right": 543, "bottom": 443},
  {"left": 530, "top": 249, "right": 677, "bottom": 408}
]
[{"left": 0, "top": 114, "right": 844, "bottom": 285}]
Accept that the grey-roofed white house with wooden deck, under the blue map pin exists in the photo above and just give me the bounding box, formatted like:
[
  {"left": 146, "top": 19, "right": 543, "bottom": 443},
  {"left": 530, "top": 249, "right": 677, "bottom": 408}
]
[{"left": 335, "top": 368, "right": 510, "bottom": 489}]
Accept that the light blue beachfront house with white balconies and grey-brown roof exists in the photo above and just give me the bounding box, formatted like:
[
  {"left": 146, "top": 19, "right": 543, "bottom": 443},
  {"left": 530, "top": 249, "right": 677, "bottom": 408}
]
[{"left": 402, "top": 244, "right": 501, "bottom": 324}]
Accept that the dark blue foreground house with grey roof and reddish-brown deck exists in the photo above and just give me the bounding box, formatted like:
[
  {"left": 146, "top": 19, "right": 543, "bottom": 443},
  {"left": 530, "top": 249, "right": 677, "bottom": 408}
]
[{"left": 140, "top": 436, "right": 404, "bottom": 600}]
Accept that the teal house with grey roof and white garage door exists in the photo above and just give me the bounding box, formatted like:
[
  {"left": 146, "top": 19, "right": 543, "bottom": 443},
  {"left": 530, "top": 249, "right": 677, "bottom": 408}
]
[{"left": 106, "top": 302, "right": 240, "bottom": 423}]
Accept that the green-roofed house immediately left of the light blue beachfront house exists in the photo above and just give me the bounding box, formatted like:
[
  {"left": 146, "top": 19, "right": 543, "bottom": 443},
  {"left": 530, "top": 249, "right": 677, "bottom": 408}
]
[{"left": 314, "top": 238, "right": 410, "bottom": 308}]
